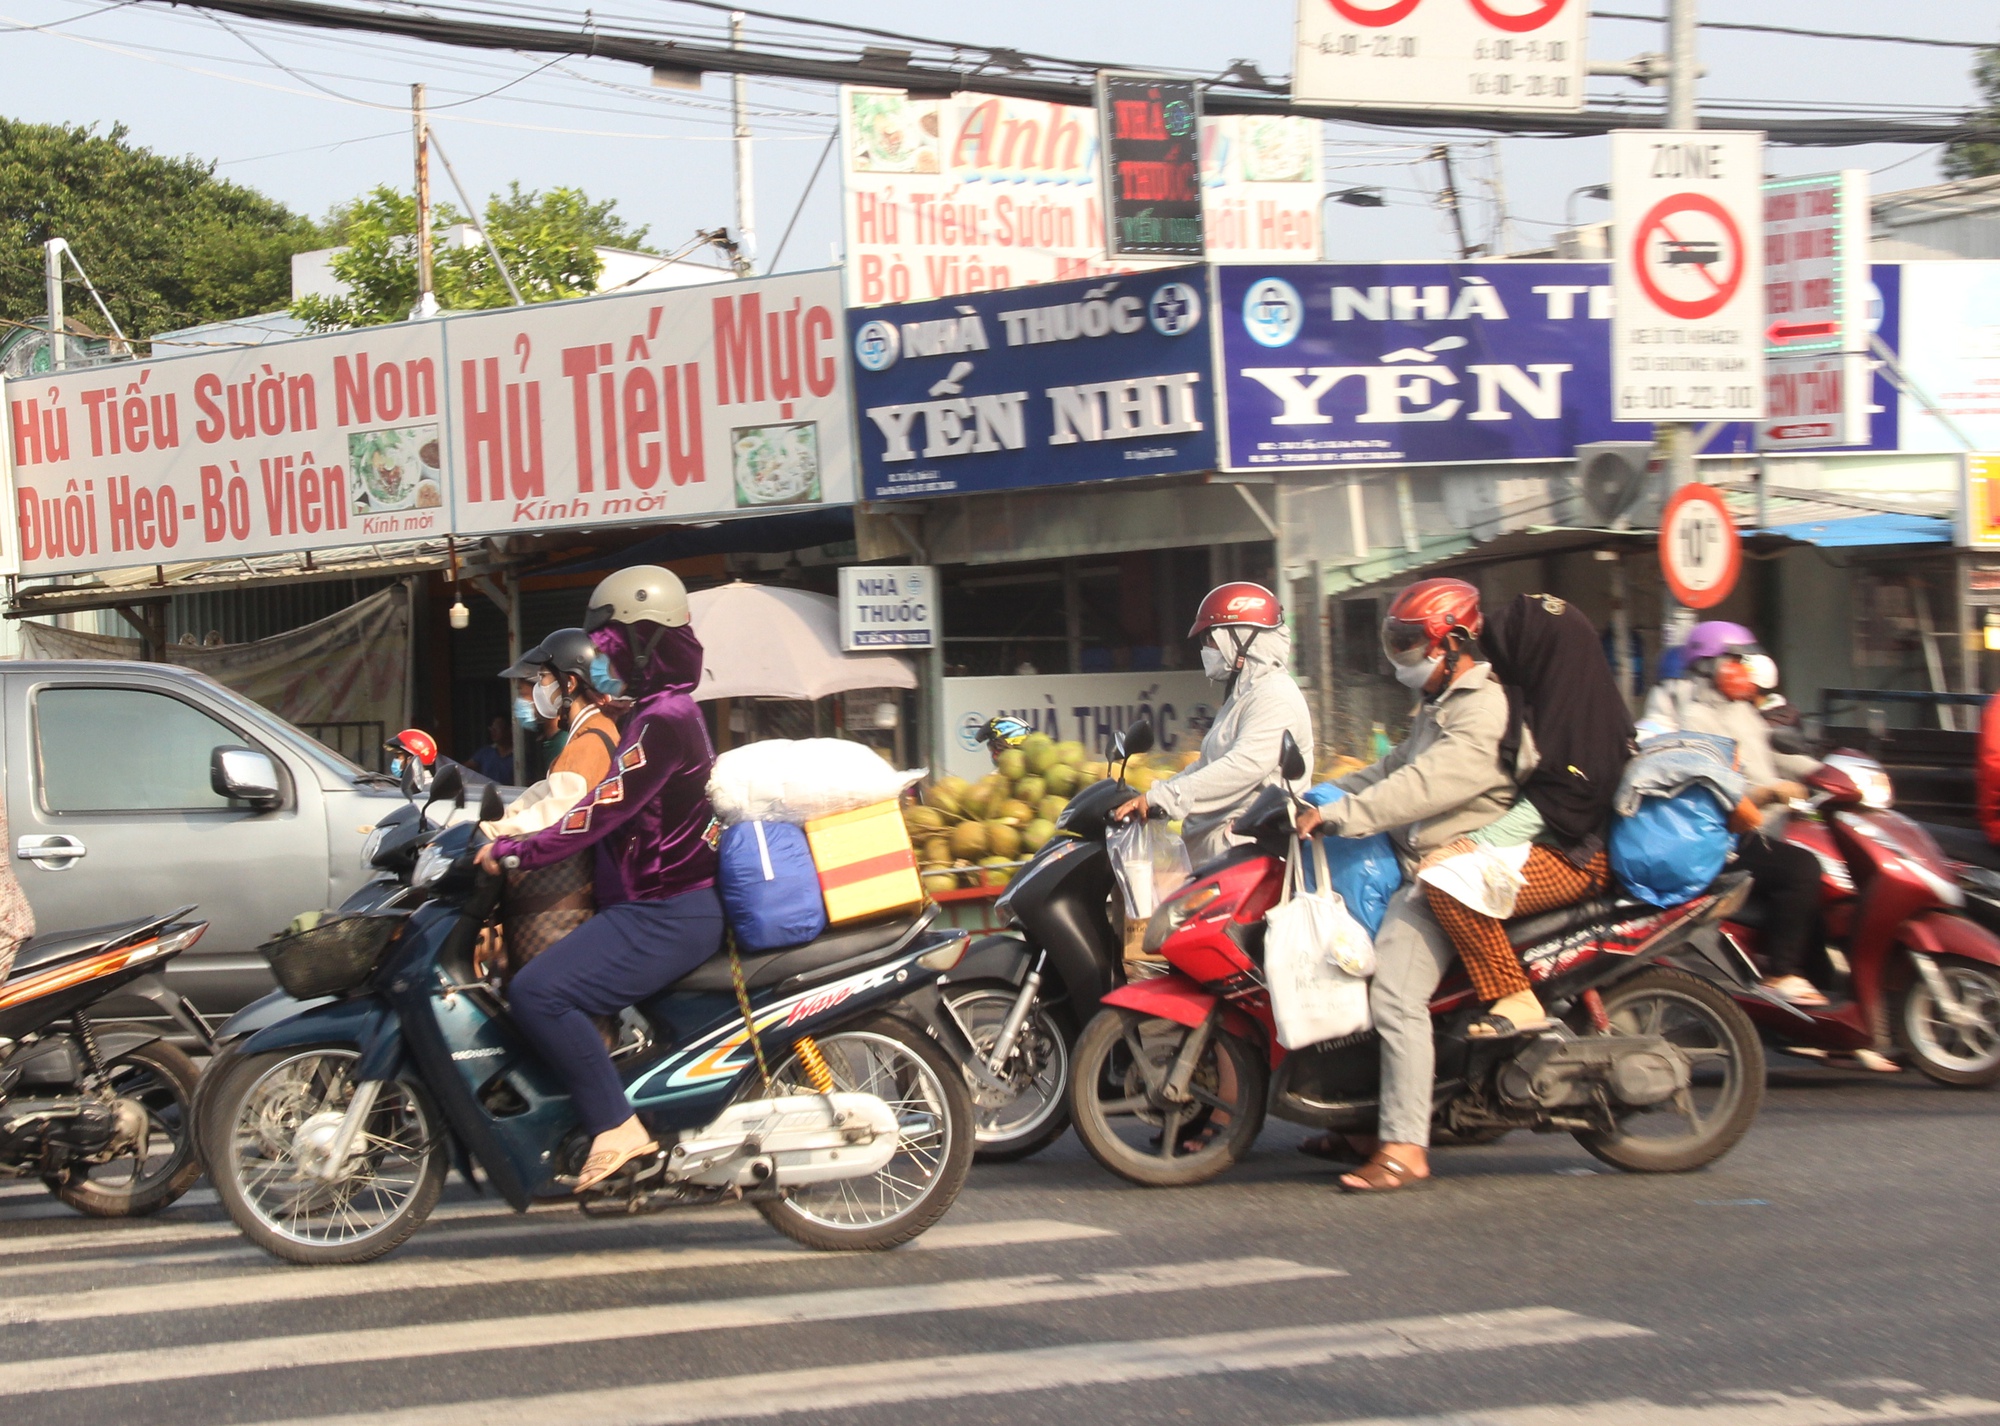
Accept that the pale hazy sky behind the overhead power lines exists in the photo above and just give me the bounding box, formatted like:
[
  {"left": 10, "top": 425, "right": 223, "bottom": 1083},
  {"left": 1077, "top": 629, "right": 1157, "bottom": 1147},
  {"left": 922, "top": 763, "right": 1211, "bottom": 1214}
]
[{"left": 0, "top": 0, "right": 2000, "bottom": 280}]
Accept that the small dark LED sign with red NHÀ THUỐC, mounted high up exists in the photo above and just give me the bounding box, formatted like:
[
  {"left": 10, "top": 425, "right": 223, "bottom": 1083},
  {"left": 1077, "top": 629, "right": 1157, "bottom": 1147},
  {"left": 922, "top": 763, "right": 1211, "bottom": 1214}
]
[{"left": 1098, "top": 70, "right": 1204, "bottom": 258}]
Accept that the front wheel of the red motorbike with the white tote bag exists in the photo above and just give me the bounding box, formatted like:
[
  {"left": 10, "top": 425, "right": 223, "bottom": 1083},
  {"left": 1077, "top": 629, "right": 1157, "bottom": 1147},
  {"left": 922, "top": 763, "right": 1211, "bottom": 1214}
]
[{"left": 1070, "top": 1008, "right": 1268, "bottom": 1188}]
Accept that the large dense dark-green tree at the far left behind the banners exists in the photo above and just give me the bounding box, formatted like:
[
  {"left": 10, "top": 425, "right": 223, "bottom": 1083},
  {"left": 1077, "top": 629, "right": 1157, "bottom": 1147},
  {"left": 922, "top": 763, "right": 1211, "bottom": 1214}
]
[{"left": 0, "top": 118, "right": 320, "bottom": 338}]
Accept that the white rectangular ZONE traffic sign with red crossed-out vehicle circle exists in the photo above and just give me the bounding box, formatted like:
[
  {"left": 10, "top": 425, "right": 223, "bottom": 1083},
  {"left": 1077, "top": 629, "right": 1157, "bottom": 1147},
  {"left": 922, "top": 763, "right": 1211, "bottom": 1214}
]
[{"left": 1612, "top": 130, "right": 1764, "bottom": 420}]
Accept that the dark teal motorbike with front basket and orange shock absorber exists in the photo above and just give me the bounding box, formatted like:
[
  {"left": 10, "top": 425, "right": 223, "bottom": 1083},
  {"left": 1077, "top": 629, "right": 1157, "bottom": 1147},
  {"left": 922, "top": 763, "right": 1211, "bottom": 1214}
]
[{"left": 200, "top": 772, "right": 984, "bottom": 1264}]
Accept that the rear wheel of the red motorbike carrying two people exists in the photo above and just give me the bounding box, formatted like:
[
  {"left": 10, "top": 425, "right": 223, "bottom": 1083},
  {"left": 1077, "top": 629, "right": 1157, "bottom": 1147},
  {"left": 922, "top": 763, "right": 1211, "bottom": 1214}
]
[{"left": 1572, "top": 966, "right": 1764, "bottom": 1174}]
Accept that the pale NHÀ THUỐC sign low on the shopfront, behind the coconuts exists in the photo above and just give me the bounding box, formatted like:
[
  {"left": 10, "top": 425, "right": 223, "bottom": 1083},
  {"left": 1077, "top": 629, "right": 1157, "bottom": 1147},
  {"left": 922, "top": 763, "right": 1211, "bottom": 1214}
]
[{"left": 944, "top": 670, "right": 1222, "bottom": 778}]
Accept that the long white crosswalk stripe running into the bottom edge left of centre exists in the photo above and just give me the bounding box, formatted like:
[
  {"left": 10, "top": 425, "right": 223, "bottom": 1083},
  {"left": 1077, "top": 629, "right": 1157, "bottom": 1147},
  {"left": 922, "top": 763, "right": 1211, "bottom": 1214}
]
[{"left": 230, "top": 1308, "right": 1650, "bottom": 1426}]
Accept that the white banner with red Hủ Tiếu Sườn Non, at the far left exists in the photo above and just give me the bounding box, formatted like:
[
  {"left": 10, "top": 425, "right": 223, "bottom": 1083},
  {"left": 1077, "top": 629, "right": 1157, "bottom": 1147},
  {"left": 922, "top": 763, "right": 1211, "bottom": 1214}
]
[{"left": 6, "top": 322, "right": 448, "bottom": 576}]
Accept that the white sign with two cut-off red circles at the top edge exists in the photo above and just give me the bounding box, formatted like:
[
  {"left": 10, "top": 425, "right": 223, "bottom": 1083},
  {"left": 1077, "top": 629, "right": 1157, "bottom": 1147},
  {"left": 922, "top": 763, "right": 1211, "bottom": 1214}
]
[{"left": 1292, "top": 0, "right": 1590, "bottom": 114}]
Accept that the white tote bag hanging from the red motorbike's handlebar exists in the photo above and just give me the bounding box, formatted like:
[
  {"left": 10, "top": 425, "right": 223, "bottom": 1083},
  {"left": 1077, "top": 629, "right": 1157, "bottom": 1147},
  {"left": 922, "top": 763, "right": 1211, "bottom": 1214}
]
[{"left": 1264, "top": 838, "right": 1374, "bottom": 1050}]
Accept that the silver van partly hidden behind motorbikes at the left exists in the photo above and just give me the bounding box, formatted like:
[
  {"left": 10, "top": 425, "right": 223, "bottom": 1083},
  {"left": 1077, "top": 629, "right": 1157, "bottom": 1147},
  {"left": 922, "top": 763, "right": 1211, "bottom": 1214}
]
[{"left": 0, "top": 660, "right": 402, "bottom": 1014}]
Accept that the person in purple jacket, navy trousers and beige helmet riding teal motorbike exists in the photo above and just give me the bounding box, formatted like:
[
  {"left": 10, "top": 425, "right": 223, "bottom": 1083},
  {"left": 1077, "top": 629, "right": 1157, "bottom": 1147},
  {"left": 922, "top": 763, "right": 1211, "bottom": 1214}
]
[{"left": 478, "top": 564, "right": 722, "bottom": 1192}]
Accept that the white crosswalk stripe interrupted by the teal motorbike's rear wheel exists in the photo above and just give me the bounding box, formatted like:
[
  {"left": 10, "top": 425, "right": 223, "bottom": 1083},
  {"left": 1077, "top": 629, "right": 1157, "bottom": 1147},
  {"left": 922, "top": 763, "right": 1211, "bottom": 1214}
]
[{"left": 0, "top": 1218, "right": 1118, "bottom": 1322}]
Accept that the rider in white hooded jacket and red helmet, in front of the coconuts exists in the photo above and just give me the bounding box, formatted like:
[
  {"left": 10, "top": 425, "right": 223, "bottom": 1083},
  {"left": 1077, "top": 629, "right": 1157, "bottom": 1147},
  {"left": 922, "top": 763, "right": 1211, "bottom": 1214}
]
[{"left": 1112, "top": 582, "right": 1312, "bottom": 866}]
